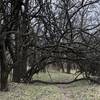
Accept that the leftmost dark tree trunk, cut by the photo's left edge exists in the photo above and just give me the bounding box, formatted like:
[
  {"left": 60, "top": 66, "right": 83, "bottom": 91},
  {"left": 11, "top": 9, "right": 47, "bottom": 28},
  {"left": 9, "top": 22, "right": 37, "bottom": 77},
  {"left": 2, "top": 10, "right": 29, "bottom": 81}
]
[{"left": 0, "top": 42, "right": 8, "bottom": 91}]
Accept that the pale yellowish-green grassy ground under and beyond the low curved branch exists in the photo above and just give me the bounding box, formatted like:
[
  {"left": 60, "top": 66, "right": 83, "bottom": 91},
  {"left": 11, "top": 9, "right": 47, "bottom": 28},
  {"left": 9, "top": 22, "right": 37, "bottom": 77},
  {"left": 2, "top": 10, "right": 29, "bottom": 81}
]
[{"left": 0, "top": 72, "right": 100, "bottom": 100}]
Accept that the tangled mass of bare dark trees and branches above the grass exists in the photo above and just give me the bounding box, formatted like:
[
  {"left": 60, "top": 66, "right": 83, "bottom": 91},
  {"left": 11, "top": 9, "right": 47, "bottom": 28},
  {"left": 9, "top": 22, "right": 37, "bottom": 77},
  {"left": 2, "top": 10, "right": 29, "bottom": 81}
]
[{"left": 0, "top": 0, "right": 100, "bottom": 90}]
